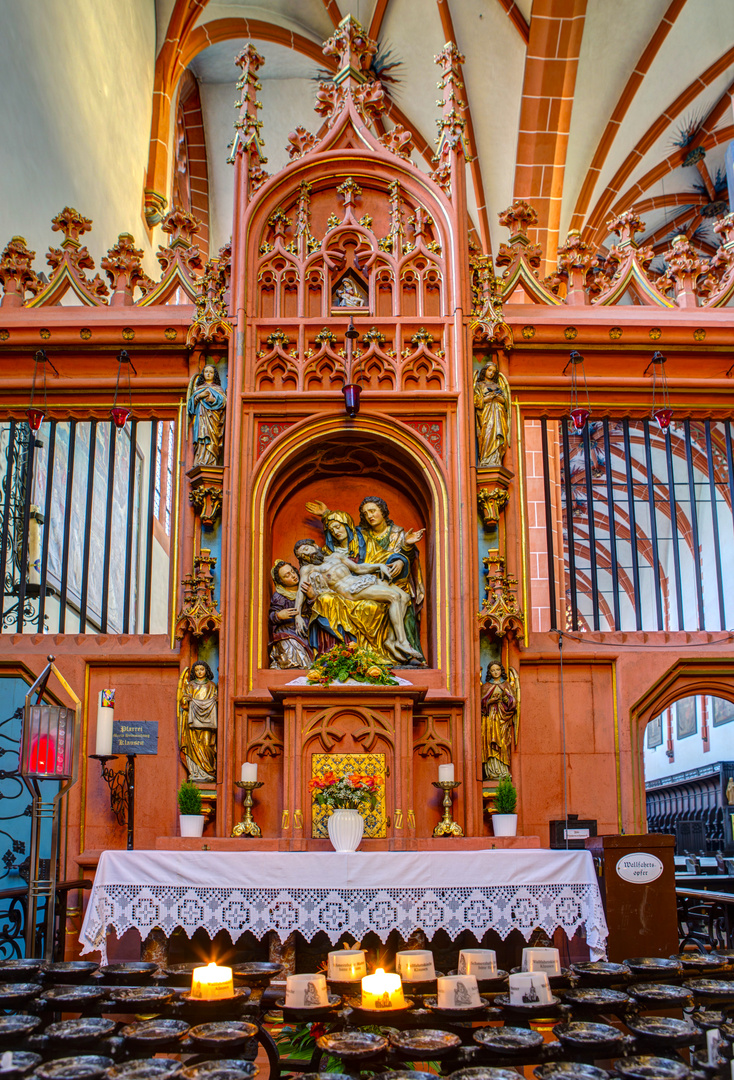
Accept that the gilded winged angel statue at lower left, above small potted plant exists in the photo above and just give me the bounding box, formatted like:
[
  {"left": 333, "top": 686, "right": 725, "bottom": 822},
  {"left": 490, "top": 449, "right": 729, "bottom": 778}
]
[{"left": 177, "top": 660, "right": 218, "bottom": 781}]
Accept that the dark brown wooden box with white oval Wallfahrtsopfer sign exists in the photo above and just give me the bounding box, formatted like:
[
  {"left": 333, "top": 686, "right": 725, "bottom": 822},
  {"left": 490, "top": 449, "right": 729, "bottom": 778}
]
[{"left": 586, "top": 833, "right": 678, "bottom": 963}]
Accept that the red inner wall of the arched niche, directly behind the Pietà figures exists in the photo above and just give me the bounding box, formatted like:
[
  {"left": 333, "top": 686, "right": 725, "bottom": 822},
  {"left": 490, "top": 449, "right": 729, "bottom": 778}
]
[{"left": 262, "top": 431, "right": 435, "bottom": 666}]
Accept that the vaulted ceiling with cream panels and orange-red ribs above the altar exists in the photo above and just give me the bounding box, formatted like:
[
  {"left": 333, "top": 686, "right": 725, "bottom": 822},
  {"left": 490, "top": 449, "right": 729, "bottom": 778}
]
[{"left": 148, "top": 0, "right": 734, "bottom": 268}]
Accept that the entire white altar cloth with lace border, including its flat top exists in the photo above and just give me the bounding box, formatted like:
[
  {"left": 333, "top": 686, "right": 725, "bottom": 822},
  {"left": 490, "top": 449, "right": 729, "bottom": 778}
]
[{"left": 80, "top": 848, "right": 607, "bottom": 962}]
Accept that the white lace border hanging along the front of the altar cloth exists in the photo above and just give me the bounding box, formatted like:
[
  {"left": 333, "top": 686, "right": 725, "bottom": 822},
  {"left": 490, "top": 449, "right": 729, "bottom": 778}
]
[{"left": 81, "top": 885, "right": 608, "bottom": 963}]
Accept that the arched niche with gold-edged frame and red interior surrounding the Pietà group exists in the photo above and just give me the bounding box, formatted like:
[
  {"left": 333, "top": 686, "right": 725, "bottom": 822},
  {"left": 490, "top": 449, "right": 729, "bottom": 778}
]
[{"left": 248, "top": 414, "right": 450, "bottom": 683}]
